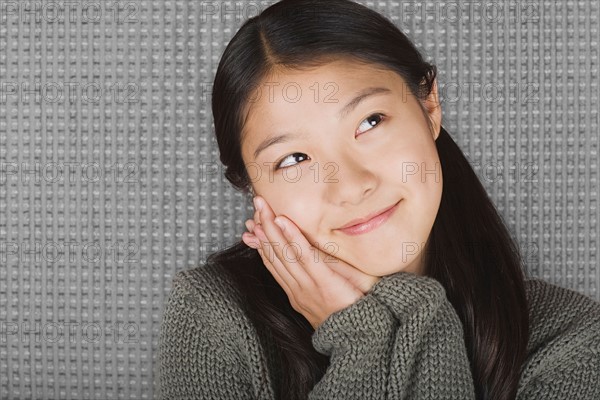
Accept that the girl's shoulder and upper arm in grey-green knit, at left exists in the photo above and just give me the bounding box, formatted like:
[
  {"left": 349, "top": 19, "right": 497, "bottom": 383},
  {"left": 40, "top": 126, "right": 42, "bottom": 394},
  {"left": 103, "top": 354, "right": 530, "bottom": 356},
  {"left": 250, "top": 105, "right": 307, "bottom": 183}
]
[{"left": 156, "top": 264, "right": 268, "bottom": 399}]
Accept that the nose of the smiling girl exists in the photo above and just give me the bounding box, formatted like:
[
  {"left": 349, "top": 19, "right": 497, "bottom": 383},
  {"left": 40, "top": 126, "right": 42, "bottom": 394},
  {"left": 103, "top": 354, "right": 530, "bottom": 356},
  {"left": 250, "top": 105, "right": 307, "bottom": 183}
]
[{"left": 323, "top": 157, "right": 377, "bottom": 207}]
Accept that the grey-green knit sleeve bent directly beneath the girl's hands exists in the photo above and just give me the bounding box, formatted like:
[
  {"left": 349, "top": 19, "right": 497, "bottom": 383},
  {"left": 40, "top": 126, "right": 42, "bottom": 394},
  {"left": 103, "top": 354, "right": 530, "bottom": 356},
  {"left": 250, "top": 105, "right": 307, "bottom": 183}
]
[{"left": 309, "top": 272, "right": 475, "bottom": 400}]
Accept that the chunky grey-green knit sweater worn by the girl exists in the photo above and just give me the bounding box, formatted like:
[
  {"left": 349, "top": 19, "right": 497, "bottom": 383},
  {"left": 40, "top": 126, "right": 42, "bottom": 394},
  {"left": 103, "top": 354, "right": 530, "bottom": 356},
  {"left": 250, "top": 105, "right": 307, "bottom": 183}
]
[{"left": 157, "top": 264, "right": 600, "bottom": 400}]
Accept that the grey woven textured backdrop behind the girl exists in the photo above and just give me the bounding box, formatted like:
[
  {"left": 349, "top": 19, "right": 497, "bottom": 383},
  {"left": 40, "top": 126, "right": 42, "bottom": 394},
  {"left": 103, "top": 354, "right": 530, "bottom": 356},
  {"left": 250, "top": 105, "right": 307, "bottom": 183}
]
[{"left": 0, "top": 0, "right": 600, "bottom": 399}]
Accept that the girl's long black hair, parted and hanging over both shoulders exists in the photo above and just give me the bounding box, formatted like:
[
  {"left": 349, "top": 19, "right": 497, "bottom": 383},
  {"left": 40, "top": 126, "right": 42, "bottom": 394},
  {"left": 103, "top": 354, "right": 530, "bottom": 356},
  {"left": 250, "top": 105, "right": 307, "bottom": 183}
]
[{"left": 207, "top": 0, "right": 529, "bottom": 400}]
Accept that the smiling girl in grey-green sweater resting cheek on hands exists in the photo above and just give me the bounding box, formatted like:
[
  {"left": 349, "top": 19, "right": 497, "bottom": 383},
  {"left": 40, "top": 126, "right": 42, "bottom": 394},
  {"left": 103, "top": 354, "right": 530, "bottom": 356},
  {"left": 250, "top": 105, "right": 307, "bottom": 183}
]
[{"left": 159, "top": 0, "right": 600, "bottom": 400}]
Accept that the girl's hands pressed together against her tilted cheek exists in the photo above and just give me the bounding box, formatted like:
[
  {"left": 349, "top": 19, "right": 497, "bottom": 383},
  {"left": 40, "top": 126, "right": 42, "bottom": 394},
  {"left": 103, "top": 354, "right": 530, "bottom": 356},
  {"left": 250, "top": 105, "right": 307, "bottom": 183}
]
[{"left": 242, "top": 196, "right": 381, "bottom": 329}]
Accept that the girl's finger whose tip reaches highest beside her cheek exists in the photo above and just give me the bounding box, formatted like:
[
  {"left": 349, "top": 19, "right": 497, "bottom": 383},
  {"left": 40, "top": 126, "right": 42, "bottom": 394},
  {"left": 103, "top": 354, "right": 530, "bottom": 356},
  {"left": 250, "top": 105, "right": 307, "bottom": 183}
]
[{"left": 259, "top": 198, "right": 315, "bottom": 288}]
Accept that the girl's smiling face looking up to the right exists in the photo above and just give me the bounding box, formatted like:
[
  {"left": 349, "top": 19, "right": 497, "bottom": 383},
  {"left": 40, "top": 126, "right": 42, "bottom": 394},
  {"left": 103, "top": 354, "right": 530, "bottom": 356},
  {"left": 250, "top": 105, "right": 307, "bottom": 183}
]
[{"left": 241, "top": 61, "right": 442, "bottom": 276}]
